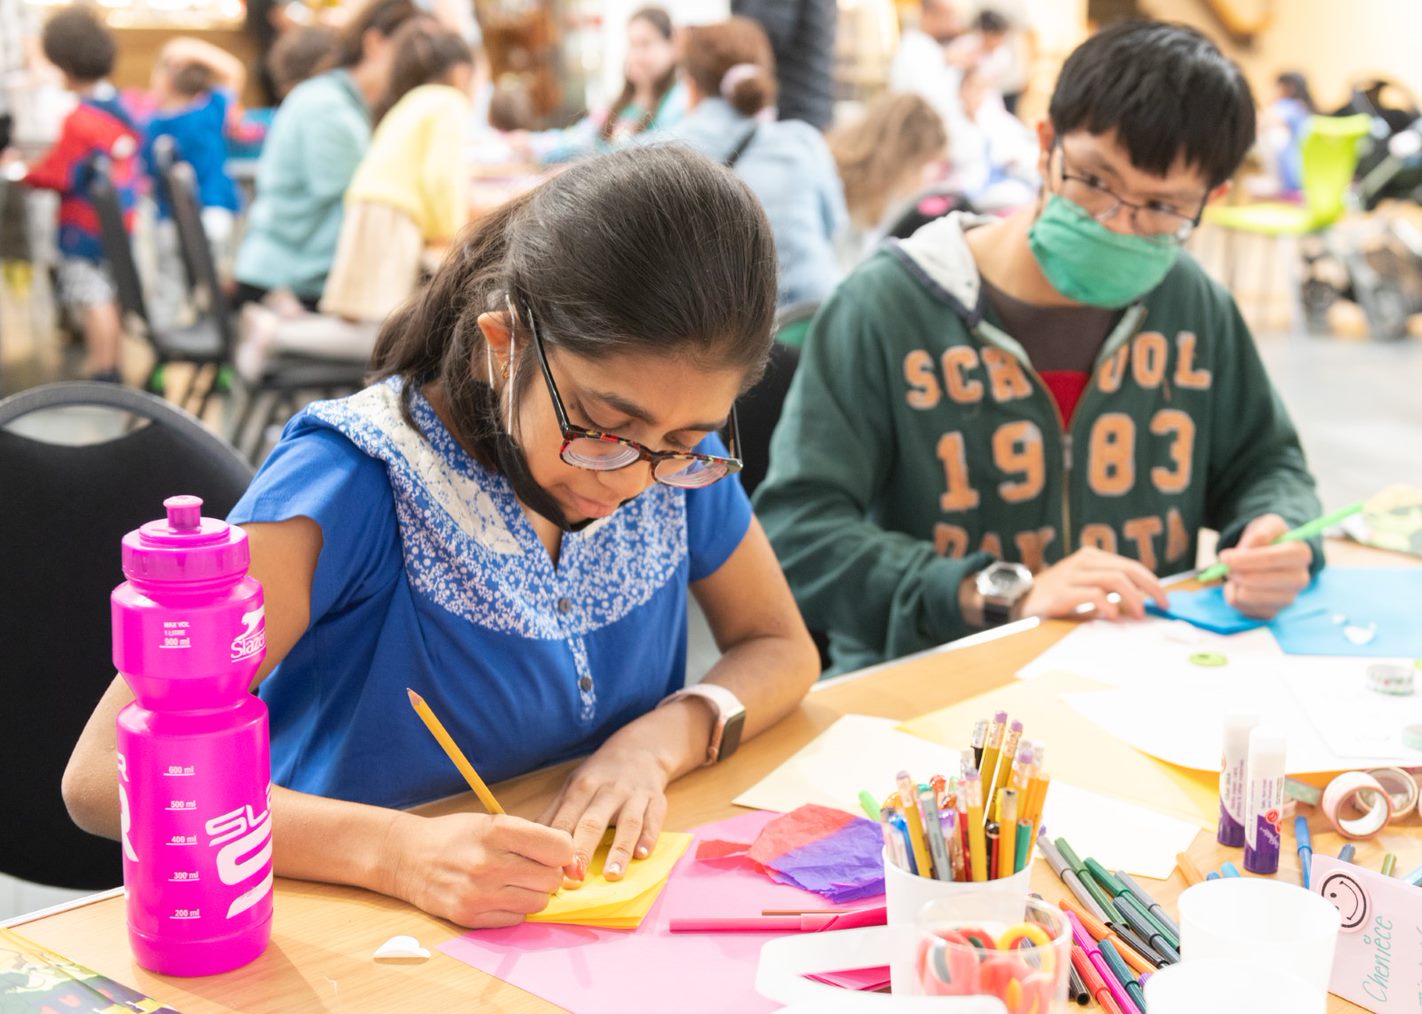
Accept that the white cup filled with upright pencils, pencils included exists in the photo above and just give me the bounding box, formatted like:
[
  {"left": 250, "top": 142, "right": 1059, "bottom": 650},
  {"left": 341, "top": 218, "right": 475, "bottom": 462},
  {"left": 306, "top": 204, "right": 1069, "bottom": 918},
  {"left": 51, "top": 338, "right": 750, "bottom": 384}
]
[{"left": 879, "top": 711, "right": 1049, "bottom": 994}]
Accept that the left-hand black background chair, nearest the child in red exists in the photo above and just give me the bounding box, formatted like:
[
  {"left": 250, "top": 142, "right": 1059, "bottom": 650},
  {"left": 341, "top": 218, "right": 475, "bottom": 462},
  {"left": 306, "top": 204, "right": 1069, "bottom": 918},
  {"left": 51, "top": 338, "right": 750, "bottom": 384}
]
[{"left": 88, "top": 151, "right": 232, "bottom": 415}]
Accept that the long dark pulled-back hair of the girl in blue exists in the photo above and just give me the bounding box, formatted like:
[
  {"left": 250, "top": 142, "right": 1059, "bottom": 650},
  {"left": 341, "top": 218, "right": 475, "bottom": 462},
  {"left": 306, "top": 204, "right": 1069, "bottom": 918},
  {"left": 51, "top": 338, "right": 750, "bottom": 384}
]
[{"left": 371, "top": 145, "right": 776, "bottom": 464}]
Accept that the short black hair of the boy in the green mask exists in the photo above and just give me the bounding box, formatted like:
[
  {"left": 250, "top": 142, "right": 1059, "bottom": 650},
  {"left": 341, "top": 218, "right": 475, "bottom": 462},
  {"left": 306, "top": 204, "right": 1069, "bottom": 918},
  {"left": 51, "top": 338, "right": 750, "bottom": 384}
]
[{"left": 1049, "top": 20, "right": 1254, "bottom": 188}]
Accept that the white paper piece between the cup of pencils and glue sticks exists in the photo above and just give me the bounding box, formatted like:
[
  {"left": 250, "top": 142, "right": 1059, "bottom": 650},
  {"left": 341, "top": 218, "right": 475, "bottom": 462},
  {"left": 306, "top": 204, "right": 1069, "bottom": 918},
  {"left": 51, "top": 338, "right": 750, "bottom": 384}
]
[{"left": 1042, "top": 782, "right": 1200, "bottom": 880}]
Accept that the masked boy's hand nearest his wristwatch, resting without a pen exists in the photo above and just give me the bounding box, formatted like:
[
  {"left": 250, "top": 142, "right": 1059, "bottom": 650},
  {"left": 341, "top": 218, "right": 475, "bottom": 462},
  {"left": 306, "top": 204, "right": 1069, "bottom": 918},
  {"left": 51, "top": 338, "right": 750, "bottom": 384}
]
[{"left": 1022, "top": 546, "right": 1166, "bottom": 620}]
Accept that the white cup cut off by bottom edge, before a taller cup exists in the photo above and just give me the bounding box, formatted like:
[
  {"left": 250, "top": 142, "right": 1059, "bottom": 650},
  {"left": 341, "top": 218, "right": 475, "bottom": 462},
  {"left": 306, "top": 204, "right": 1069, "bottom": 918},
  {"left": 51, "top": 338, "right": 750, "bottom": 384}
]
[{"left": 1146, "top": 955, "right": 1328, "bottom": 1014}]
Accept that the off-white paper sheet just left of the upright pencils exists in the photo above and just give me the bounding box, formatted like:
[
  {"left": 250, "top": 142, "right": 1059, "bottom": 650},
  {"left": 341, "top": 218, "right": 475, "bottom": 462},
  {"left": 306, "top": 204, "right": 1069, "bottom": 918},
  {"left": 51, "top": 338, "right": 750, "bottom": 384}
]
[{"left": 732, "top": 715, "right": 968, "bottom": 816}]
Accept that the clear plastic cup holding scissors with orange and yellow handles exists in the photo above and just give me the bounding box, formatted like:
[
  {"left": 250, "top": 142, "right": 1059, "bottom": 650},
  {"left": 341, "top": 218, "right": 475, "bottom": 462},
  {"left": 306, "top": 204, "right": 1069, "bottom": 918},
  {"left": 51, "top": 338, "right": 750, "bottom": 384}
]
[{"left": 912, "top": 897, "right": 1071, "bottom": 1014}]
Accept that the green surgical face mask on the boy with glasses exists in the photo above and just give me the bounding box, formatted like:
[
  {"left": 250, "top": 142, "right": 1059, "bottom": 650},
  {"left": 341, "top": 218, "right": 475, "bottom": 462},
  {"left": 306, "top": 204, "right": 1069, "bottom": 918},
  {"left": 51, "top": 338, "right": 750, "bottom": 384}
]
[{"left": 1027, "top": 193, "right": 1180, "bottom": 310}]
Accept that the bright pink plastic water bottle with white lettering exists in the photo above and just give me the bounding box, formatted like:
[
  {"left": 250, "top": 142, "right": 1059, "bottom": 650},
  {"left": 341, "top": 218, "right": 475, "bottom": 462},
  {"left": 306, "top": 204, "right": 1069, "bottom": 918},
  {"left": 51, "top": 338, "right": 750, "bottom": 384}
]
[{"left": 111, "top": 496, "right": 272, "bottom": 976}]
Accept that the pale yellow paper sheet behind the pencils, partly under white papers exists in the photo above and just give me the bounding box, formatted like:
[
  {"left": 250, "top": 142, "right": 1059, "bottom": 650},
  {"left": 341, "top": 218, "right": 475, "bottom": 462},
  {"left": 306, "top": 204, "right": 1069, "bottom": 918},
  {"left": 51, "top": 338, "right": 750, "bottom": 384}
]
[{"left": 899, "top": 673, "right": 1220, "bottom": 829}]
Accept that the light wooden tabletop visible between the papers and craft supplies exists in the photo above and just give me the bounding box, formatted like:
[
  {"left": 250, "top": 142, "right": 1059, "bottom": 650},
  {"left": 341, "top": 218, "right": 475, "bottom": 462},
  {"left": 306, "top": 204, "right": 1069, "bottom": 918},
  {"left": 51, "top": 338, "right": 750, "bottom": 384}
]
[{"left": 13, "top": 545, "right": 1422, "bottom": 1014}]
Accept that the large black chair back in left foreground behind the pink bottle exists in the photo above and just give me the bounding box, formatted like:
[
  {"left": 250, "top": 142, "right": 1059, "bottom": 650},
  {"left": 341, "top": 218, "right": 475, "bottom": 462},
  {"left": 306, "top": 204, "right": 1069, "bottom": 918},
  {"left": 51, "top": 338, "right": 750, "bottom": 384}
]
[{"left": 0, "top": 383, "right": 252, "bottom": 890}]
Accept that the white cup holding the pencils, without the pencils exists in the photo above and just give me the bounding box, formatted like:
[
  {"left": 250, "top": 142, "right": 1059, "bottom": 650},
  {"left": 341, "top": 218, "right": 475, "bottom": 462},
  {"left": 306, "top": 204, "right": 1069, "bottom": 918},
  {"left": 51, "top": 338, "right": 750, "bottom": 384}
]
[{"left": 884, "top": 856, "right": 1032, "bottom": 996}]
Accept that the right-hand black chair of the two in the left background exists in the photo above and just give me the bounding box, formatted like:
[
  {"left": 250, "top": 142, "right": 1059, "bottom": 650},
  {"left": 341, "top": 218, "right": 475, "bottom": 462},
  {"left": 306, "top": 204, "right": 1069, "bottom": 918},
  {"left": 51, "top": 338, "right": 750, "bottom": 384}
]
[{"left": 154, "top": 138, "right": 367, "bottom": 457}]
